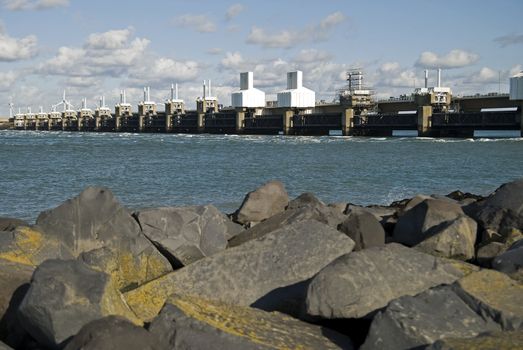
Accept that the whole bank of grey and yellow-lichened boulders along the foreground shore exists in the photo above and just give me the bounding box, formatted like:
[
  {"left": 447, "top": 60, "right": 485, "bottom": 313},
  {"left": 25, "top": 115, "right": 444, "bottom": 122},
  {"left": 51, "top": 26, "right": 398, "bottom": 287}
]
[{"left": 0, "top": 179, "right": 523, "bottom": 350}]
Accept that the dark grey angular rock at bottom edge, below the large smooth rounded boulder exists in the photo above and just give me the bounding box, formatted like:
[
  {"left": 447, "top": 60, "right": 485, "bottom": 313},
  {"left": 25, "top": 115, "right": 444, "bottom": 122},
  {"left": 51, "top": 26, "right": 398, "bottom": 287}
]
[{"left": 360, "top": 286, "right": 500, "bottom": 350}]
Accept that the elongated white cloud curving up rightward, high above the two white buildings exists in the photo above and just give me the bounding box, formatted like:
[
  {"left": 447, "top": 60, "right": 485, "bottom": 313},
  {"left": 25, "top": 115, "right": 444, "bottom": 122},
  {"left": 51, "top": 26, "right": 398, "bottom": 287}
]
[{"left": 247, "top": 12, "right": 346, "bottom": 48}]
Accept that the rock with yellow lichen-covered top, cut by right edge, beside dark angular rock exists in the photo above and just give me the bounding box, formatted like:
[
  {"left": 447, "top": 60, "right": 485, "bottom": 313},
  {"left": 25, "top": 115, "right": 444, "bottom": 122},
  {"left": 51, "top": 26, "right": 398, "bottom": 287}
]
[{"left": 456, "top": 269, "right": 523, "bottom": 331}]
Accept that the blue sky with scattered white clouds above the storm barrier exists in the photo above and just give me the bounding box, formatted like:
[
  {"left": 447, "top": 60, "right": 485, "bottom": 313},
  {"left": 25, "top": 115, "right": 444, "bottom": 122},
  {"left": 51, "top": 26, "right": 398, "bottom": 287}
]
[{"left": 0, "top": 0, "right": 523, "bottom": 116}]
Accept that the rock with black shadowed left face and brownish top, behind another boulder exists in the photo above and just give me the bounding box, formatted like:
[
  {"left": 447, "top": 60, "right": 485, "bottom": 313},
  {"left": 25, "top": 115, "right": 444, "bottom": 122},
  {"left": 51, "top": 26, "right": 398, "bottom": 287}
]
[{"left": 393, "top": 199, "right": 464, "bottom": 247}]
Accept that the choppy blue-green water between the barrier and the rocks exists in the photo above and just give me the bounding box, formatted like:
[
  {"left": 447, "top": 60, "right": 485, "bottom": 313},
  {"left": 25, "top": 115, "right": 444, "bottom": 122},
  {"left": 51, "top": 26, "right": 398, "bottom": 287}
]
[{"left": 0, "top": 131, "right": 523, "bottom": 220}]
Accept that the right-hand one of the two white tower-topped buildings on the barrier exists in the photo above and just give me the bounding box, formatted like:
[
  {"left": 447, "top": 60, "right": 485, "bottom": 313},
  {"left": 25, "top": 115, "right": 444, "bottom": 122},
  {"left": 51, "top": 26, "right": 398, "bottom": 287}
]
[{"left": 278, "top": 71, "right": 316, "bottom": 108}]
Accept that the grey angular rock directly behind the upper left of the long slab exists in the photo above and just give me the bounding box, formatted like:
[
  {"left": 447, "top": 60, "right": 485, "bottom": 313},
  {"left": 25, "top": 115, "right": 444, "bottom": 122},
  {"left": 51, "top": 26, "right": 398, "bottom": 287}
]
[{"left": 135, "top": 205, "right": 238, "bottom": 267}]
